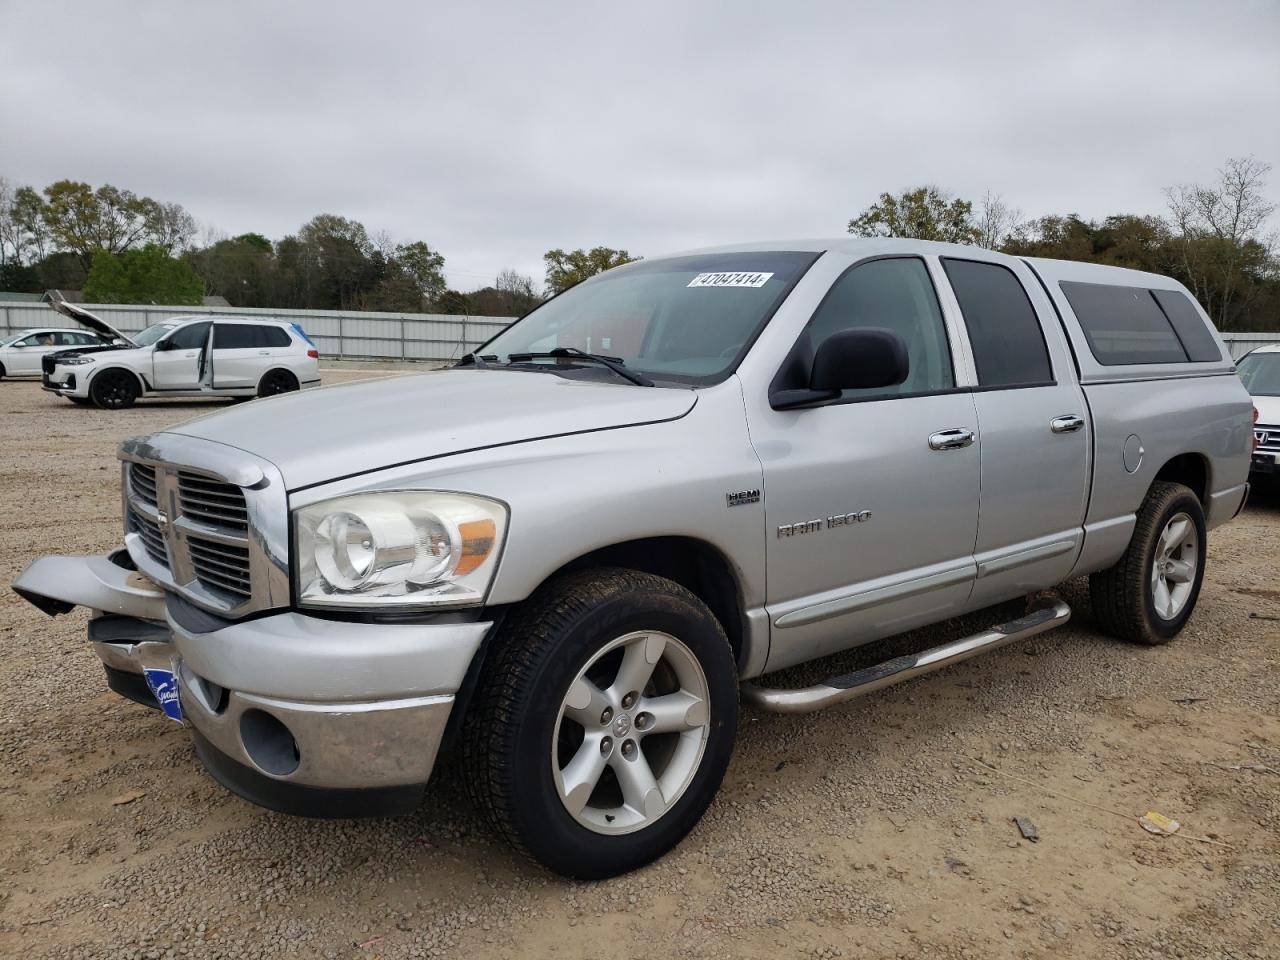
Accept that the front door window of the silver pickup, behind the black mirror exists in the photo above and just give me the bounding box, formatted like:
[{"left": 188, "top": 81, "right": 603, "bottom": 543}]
[{"left": 805, "top": 257, "right": 955, "bottom": 398}]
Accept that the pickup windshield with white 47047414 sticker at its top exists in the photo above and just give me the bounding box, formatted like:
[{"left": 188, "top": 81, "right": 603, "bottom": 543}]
[{"left": 476, "top": 252, "right": 818, "bottom": 384}]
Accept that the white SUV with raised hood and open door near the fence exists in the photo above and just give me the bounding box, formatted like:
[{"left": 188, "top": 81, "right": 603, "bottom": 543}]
[{"left": 41, "top": 302, "right": 320, "bottom": 410}]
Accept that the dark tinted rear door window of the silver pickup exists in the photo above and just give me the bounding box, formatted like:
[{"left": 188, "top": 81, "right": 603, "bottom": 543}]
[{"left": 942, "top": 257, "right": 1053, "bottom": 388}]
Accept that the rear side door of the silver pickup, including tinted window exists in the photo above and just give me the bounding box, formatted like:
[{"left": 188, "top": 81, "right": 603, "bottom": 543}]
[{"left": 942, "top": 257, "right": 1092, "bottom": 607}]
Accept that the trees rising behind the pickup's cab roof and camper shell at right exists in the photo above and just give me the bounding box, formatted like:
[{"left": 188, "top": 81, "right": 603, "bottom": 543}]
[{"left": 847, "top": 157, "right": 1280, "bottom": 332}]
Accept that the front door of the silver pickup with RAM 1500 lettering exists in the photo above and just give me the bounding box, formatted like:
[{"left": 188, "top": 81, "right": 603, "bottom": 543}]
[{"left": 749, "top": 257, "right": 979, "bottom": 671}]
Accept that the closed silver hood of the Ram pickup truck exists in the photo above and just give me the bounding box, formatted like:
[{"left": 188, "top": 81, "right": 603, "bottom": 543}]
[{"left": 166, "top": 369, "right": 698, "bottom": 490}]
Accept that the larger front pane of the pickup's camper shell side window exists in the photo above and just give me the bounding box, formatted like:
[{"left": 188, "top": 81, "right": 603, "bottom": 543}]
[{"left": 1059, "top": 280, "right": 1187, "bottom": 366}]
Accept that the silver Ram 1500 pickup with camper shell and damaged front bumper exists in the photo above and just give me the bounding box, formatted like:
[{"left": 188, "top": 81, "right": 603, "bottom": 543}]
[{"left": 14, "top": 238, "right": 1253, "bottom": 878}]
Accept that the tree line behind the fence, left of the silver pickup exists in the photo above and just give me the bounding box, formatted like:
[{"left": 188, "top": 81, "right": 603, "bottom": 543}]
[{"left": 0, "top": 178, "right": 632, "bottom": 316}]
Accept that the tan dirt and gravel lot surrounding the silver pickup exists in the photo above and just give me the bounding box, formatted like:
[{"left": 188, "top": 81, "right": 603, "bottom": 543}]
[{"left": 0, "top": 371, "right": 1280, "bottom": 960}]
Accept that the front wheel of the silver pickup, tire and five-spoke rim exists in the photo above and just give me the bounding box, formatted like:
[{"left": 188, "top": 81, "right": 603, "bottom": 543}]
[{"left": 463, "top": 570, "right": 737, "bottom": 879}]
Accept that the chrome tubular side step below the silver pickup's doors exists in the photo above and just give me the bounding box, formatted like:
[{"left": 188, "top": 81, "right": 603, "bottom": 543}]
[{"left": 741, "top": 600, "right": 1071, "bottom": 713}]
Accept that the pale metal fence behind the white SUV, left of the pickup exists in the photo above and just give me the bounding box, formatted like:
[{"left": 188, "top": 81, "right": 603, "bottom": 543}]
[{"left": 0, "top": 303, "right": 515, "bottom": 362}]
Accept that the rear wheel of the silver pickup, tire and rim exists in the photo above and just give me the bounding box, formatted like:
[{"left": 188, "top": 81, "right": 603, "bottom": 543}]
[{"left": 1089, "top": 481, "right": 1206, "bottom": 645}]
